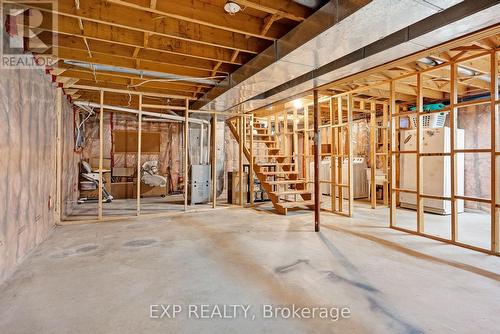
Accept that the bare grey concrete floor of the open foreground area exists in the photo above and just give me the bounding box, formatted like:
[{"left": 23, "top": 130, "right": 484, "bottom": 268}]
[{"left": 0, "top": 206, "right": 500, "bottom": 333}]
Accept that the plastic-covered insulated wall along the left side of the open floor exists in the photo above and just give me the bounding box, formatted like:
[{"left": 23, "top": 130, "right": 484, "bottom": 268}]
[{"left": 0, "top": 69, "right": 67, "bottom": 281}]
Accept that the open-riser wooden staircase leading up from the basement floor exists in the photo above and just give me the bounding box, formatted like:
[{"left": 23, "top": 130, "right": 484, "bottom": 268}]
[{"left": 228, "top": 119, "right": 314, "bottom": 215}]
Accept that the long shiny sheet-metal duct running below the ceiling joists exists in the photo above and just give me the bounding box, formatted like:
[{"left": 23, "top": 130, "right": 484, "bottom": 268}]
[{"left": 193, "top": 0, "right": 500, "bottom": 112}]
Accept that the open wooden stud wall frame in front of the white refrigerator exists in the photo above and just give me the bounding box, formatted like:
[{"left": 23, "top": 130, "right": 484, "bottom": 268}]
[{"left": 382, "top": 50, "right": 500, "bottom": 255}]
